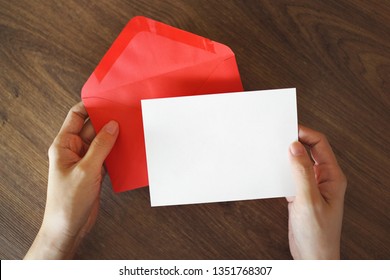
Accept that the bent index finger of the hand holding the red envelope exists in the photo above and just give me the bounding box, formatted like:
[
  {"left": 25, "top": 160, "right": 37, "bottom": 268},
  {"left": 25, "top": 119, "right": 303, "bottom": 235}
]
[{"left": 59, "top": 102, "right": 88, "bottom": 134}]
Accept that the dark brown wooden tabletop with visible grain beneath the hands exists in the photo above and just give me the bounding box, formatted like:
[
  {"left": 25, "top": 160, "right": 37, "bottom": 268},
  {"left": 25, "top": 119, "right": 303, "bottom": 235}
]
[{"left": 0, "top": 0, "right": 390, "bottom": 259}]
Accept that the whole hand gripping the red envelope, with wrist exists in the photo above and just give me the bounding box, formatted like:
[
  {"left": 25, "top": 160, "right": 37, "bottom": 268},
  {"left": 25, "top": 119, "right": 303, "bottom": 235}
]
[{"left": 25, "top": 102, "right": 119, "bottom": 259}]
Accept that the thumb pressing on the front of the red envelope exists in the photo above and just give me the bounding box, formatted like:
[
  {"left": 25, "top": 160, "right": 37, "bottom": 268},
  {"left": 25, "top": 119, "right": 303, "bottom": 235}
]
[{"left": 82, "top": 121, "right": 119, "bottom": 168}]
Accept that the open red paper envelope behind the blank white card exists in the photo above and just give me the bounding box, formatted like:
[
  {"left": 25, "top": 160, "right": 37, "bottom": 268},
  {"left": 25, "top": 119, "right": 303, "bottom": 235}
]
[{"left": 81, "top": 16, "right": 243, "bottom": 192}]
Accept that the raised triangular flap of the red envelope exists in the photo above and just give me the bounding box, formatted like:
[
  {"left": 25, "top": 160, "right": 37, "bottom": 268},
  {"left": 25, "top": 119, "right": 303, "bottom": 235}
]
[{"left": 82, "top": 17, "right": 234, "bottom": 97}]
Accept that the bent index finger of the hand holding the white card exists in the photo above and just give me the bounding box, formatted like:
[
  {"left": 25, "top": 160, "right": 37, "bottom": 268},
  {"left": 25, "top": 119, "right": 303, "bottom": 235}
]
[{"left": 298, "top": 125, "right": 337, "bottom": 165}]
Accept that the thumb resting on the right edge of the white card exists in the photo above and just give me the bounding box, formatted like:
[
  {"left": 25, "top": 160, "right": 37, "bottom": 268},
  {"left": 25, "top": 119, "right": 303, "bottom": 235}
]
[{"left": 290, "top": 141, "right": 320, "bottom": 201}]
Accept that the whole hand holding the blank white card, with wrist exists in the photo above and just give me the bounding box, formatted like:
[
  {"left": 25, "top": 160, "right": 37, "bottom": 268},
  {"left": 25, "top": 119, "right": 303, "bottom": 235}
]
[{"left": 287, "top": 126, "right": 347, "bottom": 259}]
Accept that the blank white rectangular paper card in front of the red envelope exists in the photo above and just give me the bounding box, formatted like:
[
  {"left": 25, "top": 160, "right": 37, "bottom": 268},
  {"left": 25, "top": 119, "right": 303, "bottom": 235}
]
[{"left": 141, "top": 89, "right": 298, "bottom": 206}]
